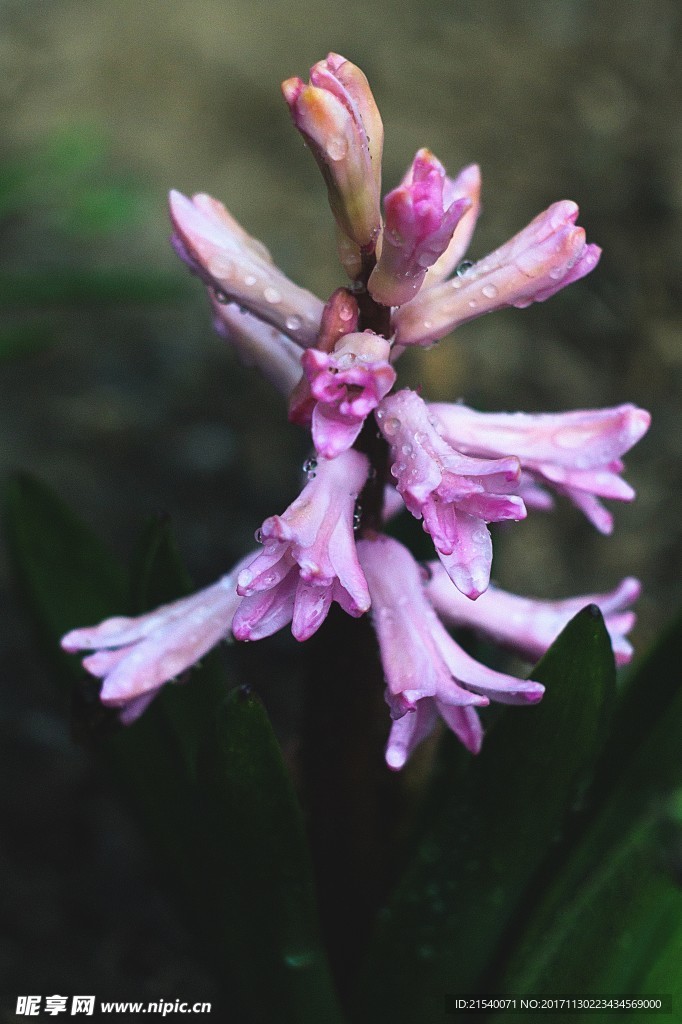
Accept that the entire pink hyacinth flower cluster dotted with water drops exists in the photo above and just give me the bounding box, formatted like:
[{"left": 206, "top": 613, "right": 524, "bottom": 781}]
[{"left": 62, "top": 53, "right": 649, "bottom": 769}]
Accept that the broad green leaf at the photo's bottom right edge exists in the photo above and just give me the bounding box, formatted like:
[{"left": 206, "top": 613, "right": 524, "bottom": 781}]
[{"left": 485, "top": 602, "right": 682, "bottom": 993}]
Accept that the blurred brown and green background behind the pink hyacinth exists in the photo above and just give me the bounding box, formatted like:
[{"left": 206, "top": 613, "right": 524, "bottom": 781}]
[{"left": 0, "top": 0, "right": 682, "bottom": 998}]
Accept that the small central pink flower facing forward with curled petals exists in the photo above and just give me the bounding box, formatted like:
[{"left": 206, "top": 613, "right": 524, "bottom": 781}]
[{"left": 301, "top": 331, "right": 396, "bottom": 459}]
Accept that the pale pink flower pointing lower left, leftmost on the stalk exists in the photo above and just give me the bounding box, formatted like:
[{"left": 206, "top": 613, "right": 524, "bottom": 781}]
[{"left": 61, "top": 553, "right": 253, "bottom": 724}]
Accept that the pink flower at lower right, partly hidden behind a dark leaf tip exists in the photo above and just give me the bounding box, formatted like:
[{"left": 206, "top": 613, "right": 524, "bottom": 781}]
[{"left": 426, "top": 562, "right": 641, "bottom": 665}]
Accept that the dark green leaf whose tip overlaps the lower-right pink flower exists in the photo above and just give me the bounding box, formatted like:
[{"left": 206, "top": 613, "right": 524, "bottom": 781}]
[{"left": 352, "top": 607, "right": 615, "bottom": 1024}]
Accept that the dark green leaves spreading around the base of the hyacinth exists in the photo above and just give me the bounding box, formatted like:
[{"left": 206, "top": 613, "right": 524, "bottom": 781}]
[{"left": 6, "top": 477, "right": 682, "bottom": 1024}]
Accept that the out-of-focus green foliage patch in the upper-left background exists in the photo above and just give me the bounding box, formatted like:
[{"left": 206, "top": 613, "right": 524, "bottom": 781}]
[{"left": 0, "top": 127, "right": 186, "bottom": 359}]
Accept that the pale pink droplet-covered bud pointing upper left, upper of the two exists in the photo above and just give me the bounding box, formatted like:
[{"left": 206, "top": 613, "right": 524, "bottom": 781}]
[{"left": 170, "top": 191, "right": 324, "bottom": 346}]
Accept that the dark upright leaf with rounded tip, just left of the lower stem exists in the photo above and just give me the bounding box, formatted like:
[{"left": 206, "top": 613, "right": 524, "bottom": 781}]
[{"left": 200, "top": 690, "right": 341, "bottom": 1024}]
